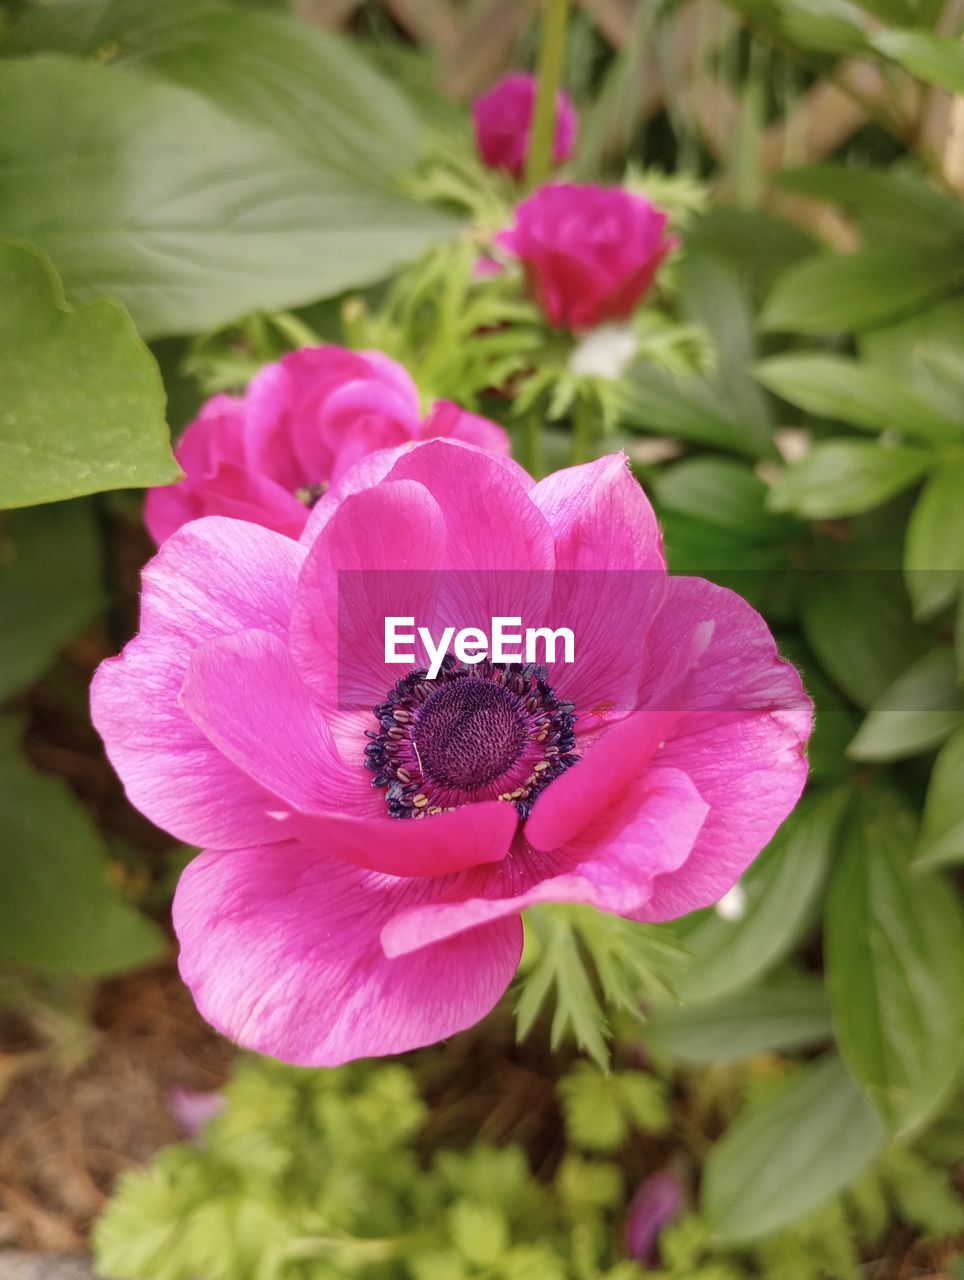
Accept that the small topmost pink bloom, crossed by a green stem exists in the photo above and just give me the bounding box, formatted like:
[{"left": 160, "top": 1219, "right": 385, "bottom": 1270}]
[{"left": 472, "top": 72, "right": 579, "bottom": 178}]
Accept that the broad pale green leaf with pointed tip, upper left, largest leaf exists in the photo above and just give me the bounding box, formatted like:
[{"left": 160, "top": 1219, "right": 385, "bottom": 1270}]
[{"left": 0, "top": 58, "right": 456, "bottom": 335}]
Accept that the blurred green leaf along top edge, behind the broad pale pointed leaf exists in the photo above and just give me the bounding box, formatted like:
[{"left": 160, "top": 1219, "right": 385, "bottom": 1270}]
[{"left": 8, "top": 0, "right": 420, "bottom": 186}]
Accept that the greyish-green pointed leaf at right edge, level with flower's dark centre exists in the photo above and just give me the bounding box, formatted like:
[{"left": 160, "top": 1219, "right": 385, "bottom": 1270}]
[{"left": 848, "top": 648, "right": 964, "bottom": 760}]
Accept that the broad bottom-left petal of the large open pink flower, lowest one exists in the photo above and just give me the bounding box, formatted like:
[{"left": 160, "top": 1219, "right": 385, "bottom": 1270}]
[{"left": 174, "top": 844, "right": 522, "bottom": 1066}]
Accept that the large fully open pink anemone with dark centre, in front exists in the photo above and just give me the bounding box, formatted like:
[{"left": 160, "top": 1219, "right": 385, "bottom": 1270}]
[{"left": 92, "top": 445, "right": 810, "bottom": 1065}]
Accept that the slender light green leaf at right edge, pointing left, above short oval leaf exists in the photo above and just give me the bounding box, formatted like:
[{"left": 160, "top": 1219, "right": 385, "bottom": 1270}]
[{"left": 757, "top": 353, "right": 964, "bottom": 444}]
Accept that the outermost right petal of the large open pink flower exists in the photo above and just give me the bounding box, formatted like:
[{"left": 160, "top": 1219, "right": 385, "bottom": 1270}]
[{"left": 640, "top": 579, "right": 812, "bottom": 920}]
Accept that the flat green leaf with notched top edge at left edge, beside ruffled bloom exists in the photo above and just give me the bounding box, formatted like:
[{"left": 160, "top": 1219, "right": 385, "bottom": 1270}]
[{"left": 0, "top": 241, "right": 181, "bottom": 507}]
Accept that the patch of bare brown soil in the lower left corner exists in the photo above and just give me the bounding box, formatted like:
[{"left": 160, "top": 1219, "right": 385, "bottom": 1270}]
[{"left": 0, "top": 963, "right": 233, "bottom": 1251}]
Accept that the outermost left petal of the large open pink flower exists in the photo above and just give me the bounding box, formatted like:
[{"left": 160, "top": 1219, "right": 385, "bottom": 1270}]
[{"left": 91, "top": 517, "right": 305, "bottom": 847}]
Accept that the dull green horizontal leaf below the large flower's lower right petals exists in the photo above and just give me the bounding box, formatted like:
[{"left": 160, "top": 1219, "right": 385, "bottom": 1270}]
[{"left": 645, "top": 974, "right": 832, "bottom": 1066}]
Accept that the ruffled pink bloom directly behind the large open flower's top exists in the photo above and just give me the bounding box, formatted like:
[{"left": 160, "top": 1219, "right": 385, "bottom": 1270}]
[{"left": 145, "top": 347, "right": 508, "bottom": 544}]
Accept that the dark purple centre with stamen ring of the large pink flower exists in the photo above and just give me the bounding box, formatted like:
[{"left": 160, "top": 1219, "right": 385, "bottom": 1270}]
[{"left": 365, "top": 654, "right": 579, "bottom": 818}]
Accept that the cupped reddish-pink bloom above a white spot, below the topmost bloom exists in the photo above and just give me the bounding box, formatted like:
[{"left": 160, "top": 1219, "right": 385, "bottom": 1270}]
[{"left": 495, "top": 183, "right": 676, "bottom": 332}]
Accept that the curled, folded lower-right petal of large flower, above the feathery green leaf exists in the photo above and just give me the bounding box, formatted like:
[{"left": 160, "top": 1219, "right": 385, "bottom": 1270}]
[{"left": 382, "top": 769, "right": 707, "bottom": 956}]
